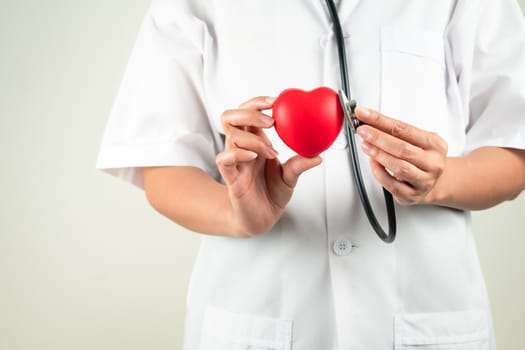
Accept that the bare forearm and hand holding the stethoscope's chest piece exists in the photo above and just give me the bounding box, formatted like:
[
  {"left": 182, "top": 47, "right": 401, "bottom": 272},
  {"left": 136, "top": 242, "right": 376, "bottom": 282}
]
[{"left": 357, "top": 107, "right": 525, "bottom": 210}]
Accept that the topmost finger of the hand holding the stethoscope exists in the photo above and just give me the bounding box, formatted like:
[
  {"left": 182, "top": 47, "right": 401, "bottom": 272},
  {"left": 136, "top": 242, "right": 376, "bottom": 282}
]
[{"left": 356, "top": 107, "right": 446, "bottom": 152}]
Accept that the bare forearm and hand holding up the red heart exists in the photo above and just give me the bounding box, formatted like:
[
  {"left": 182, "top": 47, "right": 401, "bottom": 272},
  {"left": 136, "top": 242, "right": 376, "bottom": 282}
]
[{"left": 143, "top": 97, "right": 321, "bottom": 237}]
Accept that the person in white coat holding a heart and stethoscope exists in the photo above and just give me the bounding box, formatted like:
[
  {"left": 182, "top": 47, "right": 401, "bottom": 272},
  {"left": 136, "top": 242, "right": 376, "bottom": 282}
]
[{"left": 98, "top": 0, "right": 525, "bottom": 350}]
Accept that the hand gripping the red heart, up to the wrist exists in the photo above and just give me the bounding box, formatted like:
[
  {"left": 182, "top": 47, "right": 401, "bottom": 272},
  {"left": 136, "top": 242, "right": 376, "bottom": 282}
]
[{"left": 216, "top": 97, "right": 321, "bottom": 237}]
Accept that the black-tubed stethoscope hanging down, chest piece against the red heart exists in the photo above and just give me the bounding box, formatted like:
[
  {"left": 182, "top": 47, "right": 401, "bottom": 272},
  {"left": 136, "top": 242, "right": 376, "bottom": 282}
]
[{"left": 326, "top": 0, "right": 396, "bottom": 243}]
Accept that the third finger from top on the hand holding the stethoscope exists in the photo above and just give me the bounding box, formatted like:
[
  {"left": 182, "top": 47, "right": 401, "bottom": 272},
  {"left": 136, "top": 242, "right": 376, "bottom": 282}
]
[{"left": 361, "top": 142, "right": 426, "bottom": 187}]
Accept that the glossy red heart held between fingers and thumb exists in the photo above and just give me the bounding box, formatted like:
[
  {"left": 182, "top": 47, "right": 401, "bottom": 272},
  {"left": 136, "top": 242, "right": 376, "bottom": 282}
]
[{"left": 272, "top": 87, "right": 344, "bottom": 157}]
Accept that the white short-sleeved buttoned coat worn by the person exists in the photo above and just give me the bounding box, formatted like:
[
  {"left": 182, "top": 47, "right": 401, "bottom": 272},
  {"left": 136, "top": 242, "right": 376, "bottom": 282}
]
[{"left": 98, "top": 0, "right": 525, "bottom": 350}]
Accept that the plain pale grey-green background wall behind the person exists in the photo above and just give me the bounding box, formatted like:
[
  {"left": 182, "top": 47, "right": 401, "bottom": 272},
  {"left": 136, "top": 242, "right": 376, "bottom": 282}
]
[{"left": 0, "top": 0, "right": 525, "bottom": 350}]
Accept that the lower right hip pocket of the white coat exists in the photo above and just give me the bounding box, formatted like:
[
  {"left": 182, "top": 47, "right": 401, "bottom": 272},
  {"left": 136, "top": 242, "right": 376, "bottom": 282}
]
[{"left": 394, "top": 310, "right": 489, "bottom": 350}]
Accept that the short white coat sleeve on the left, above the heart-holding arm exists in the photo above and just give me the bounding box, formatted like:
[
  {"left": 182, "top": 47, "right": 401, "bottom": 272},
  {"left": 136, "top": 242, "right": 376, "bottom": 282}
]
[{"left": 97, "top": 0, "right": 220, "bottom": 187}]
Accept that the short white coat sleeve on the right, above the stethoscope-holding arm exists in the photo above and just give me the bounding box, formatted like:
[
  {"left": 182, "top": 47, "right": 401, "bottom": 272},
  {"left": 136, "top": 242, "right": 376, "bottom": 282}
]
[{"left": 448, "top": 0, "right": 525, "bottom": 153}]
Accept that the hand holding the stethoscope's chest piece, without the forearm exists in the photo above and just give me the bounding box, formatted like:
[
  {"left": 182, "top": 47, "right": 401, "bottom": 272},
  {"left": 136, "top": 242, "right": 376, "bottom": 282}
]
[{"left": 356, "top": 107, "right": 448, "bottom": 205}]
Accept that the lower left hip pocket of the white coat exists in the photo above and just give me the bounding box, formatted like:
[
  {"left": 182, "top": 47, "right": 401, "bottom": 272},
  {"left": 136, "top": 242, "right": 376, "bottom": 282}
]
[{"left": 200, "top": 306, "right": 293, "bottom": 350}]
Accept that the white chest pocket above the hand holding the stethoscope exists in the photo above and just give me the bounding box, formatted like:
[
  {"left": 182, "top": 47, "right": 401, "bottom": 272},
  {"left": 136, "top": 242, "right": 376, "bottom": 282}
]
[{"left": 381, "top": 24, "right": 448, "bottom": 136}]
